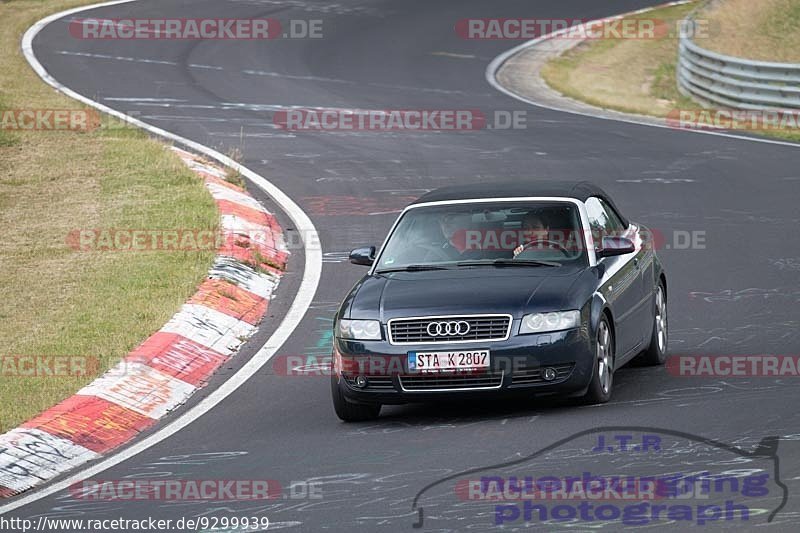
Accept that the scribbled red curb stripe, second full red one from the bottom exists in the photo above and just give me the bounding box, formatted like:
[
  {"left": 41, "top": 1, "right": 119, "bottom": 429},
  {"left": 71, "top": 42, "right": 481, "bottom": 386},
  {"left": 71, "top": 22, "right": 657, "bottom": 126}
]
[{"left": 125, "top": 331, "right": 228, "bottom": 387}]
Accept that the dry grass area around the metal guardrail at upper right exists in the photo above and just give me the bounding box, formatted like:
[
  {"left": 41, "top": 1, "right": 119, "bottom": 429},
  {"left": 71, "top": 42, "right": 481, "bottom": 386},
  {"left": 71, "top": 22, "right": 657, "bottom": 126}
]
[{"left": 542, "top": 0, "right": 800, "bottom": 141}]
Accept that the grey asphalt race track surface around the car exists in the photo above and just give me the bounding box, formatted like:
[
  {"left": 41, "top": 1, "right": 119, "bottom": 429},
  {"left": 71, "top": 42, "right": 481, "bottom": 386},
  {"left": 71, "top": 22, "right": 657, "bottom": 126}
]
[{"left": 10, "top": 0, "right": 800, "bottom": 531}]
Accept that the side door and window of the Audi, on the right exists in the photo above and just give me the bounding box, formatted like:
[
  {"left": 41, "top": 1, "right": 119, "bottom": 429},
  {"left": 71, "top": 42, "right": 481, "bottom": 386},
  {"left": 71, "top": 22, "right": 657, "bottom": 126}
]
[{"left": 586, "top": 198, "right": 645, "bottom": 358}]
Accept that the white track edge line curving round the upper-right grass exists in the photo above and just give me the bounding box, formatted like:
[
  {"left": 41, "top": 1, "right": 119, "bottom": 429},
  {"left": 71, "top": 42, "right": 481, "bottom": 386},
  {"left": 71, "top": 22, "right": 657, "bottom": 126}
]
[{"left": 485, "top": 0, "right": 800, "bottom": 148}]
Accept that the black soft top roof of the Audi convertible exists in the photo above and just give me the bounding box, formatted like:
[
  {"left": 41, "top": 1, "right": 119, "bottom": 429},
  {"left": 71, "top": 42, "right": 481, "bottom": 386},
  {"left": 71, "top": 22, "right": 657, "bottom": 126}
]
[{"left": 412, "top": 180, "right": 628, "bottom": 225}]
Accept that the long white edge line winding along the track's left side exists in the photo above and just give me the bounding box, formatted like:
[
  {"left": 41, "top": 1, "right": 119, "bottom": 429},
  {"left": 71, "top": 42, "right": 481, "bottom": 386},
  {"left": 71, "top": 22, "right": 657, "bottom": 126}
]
[{"left": 0, "top": 0, "right": 322, "bottom": 515}]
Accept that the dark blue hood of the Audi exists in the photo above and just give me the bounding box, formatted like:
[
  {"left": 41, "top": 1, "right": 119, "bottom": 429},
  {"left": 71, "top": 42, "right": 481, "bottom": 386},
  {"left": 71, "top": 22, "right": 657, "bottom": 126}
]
[{"left": 340, "top": 267, "right": 585, "bottom": 322}]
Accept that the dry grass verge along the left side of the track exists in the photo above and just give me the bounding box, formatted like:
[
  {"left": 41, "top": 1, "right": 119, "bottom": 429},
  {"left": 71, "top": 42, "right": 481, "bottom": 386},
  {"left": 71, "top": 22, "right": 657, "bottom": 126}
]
[{"left": 0, "top": 0, "right": 219, "bottom": 433}]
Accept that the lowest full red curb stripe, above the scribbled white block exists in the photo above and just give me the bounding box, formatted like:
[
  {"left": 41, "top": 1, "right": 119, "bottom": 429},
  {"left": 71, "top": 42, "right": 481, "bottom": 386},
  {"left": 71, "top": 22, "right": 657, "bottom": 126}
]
[{"left": 22, "top": 394, "right": 155, "bottom": 453}]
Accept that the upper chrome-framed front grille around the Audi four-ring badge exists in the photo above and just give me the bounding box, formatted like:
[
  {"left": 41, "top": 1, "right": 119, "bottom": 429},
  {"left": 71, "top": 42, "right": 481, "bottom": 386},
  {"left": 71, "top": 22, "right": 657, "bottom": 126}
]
[{"left": 389, "top": 315, "right": 511, "bottom": 344}]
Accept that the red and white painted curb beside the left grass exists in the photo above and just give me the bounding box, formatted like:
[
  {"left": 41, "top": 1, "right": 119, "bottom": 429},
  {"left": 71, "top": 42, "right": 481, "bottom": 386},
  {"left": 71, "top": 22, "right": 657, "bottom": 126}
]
[{"left": 0, "top": 148, "right": 289, "bottom": 498}]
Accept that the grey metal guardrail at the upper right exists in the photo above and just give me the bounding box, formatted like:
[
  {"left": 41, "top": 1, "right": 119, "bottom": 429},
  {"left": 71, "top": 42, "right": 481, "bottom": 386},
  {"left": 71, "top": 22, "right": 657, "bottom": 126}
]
[{"left": 678, "top": 19, "right": 800, "bottom": 110}]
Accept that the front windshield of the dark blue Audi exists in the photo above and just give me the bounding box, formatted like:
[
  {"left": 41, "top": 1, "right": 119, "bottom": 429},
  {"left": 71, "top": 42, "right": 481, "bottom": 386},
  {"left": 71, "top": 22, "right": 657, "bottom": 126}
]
[{"left": 376, "top": 201, "right": 587, "bottom": 272}]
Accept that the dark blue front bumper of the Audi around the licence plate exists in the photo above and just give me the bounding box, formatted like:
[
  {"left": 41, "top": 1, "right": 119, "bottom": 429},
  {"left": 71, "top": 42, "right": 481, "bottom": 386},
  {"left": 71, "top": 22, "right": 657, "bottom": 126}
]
[{"left": 333, "top": 328, "right": 594, "bottom": 404}]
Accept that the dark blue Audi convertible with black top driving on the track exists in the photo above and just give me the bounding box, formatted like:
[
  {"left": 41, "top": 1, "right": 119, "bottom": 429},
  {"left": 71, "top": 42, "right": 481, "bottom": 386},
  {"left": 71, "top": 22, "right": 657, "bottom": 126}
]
[{"left": 331, "top": 182, "right": 667, "bottom": 421}]
